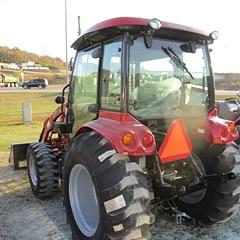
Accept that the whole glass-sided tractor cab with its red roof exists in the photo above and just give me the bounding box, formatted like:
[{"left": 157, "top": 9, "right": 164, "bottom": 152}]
[{"left": 69, "top": 18, "right": 234, "bottom": 151}]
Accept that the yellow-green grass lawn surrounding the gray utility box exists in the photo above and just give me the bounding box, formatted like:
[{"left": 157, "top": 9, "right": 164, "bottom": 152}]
[{"left": 0, "top": 93, "right": 58, "bottom": 152}]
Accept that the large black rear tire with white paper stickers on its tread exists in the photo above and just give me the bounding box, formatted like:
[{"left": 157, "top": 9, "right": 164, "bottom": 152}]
[{"left": 64, "top": 132, "right": 154, "bottom": 240}]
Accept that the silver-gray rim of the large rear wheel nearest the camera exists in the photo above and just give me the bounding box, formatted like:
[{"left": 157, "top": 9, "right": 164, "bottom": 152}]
[{"left": 69, "top": 164, "right": 100, "bottom": 237}]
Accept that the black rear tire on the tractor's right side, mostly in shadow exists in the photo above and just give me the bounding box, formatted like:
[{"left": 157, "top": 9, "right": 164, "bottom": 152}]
[{"left": 176, "top": 144, "right": 240, "bottom": 225}]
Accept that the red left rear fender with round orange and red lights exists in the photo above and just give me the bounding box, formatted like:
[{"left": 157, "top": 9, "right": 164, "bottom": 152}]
[{"left": 76, "top": 111, "right": 156, "bottom": 156}]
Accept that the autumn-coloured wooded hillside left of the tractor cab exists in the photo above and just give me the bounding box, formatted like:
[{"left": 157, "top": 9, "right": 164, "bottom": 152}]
[{"left": 0, "top": 47, "right": 65, "bottom": 70}]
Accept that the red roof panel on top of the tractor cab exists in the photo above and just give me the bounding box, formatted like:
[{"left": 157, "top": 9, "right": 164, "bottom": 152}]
[{"left": 72, "top": 17, "right": 209, "bottom": 49}]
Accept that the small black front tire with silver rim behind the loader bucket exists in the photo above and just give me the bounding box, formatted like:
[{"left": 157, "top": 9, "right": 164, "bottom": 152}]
[{"left": 27, "top": 143, "right": 59, "bottom": 199}]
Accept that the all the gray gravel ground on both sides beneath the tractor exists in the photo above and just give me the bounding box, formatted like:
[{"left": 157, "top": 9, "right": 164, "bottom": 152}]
[{"left": 0, "top": 154, "right": 240, "bottom": 240}]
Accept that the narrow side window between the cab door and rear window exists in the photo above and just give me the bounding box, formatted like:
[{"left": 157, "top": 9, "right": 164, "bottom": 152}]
[{"left": 101, "top": 42, "right": 122, "bottom": 110}]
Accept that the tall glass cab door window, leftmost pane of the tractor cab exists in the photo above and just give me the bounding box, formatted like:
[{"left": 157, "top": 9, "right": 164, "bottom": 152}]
[{"left": 70, "top": 49, "right": 99, "bottom": 133}]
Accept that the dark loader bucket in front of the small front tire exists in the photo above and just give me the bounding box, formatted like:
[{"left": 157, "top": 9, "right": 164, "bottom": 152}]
[{"left": 9, "top": 142, "right": 31, "bottom": 170}]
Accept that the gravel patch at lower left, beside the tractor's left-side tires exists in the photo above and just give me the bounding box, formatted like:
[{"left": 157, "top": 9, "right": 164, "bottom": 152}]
[{"left": 0, "top": 166, "right": 71, "bottom": 240}]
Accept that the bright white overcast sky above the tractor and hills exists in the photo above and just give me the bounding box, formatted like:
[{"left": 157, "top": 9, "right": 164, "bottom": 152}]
[{"left": 0, "top": 0, "right": 240, "bottom": 72}]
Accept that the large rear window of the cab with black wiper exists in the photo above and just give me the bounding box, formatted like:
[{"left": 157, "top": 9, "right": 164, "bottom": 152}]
[{"left": 129, "top": 37, "right": 210, "bottom": 119}]
